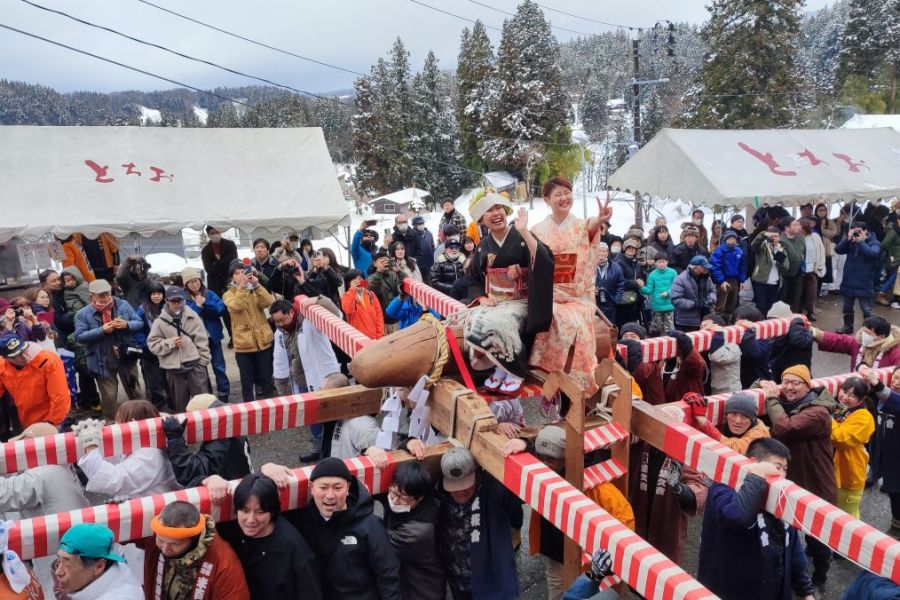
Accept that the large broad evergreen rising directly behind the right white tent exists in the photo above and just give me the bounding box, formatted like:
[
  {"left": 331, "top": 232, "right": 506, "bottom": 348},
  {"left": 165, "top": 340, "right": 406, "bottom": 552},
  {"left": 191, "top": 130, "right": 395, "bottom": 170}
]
[{"left": 684, "top": 0, "right": 803, "bottom": 129}]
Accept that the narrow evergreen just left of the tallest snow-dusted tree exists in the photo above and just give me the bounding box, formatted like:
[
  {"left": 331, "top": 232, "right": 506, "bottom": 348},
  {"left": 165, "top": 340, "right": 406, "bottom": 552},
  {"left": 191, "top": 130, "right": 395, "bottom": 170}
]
[{"left": 456, "top": 21, "right": 494, "bottom": 171}]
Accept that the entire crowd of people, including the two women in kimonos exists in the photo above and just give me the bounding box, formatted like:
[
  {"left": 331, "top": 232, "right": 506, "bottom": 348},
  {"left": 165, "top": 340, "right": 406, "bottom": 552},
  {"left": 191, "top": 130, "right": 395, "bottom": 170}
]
[{"left": 0, "top": 190, "right": 900, "bottom": 600}]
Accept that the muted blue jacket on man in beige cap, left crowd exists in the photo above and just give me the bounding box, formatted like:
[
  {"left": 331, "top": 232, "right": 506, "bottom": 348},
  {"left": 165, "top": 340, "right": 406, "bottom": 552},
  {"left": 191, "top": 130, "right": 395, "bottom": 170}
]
[{"left": 75, "top": 298, "right": 144, "bottom": 379}]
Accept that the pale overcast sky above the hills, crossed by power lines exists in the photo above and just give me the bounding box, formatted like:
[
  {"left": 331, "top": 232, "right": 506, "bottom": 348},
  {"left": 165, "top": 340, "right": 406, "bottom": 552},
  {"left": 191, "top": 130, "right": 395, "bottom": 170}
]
[{"left": 0, "top": 0, "right": 831, "bottom": 92}]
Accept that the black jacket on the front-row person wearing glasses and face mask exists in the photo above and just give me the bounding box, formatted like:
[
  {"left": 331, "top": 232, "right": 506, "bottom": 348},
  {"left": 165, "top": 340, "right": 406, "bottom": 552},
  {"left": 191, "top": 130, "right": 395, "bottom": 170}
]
[{"left": 385, "top": 495, "right": 447, "bottom": 600}]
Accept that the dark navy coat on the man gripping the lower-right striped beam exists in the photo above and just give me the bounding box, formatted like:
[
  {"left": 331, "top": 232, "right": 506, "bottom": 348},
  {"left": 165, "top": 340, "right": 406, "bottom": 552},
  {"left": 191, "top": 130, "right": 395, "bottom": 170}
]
[{"left": 697, "top": 475, "right": 813, "bottom": 600}]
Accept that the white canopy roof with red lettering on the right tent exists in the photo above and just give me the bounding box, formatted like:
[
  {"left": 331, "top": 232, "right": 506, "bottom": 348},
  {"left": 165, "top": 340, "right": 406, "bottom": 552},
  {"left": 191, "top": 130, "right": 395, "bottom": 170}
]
[{"left": 608, "top": 128, "right": 900, "bottom": 206}]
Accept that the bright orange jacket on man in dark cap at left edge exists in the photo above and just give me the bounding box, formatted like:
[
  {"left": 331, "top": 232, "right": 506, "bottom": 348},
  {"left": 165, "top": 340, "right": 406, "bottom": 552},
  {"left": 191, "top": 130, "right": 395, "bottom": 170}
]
[{"left": 0, "top": 350, "right": 72, "bottom": 429}]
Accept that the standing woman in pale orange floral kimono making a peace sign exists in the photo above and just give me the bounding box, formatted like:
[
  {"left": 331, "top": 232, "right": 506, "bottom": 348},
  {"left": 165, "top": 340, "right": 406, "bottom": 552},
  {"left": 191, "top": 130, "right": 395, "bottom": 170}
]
[{"left": 520, "top": 177, "right": 612, "bottom": 397}]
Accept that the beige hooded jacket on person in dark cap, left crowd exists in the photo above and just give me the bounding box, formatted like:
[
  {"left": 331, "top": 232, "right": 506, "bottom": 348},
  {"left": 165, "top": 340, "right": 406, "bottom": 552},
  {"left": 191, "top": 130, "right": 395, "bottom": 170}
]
[{"left": 147, "top": 307, "right": 210, "bottom": 371}]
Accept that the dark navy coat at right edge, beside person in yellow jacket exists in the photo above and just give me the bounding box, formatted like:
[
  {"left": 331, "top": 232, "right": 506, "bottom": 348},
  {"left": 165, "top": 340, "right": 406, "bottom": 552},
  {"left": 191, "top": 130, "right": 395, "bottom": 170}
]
[{"left": 869, "top": 383, "right": 900, "bottom": 494}]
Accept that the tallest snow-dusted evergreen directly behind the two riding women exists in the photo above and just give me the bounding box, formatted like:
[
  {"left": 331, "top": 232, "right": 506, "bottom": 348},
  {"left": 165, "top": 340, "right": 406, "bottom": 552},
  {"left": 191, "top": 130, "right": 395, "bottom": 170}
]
[{"left": 481, "top": 0, "right": 569, "bottom": 187}]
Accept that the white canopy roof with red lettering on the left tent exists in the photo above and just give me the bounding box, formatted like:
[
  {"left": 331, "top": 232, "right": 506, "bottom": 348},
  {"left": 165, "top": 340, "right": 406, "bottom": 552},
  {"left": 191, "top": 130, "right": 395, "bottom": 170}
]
[{"left": 0, "top": 126, "right": 349, "bottom": 242}]
